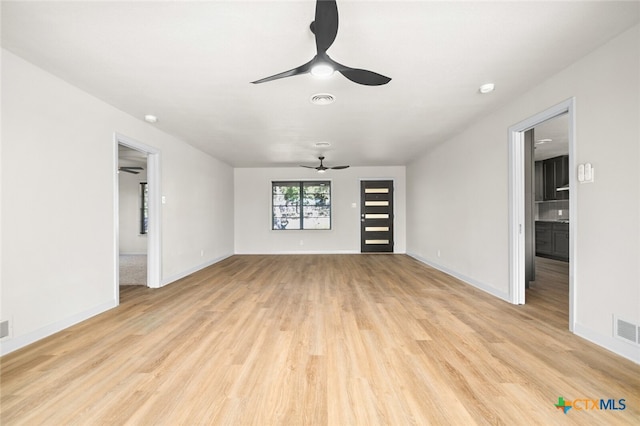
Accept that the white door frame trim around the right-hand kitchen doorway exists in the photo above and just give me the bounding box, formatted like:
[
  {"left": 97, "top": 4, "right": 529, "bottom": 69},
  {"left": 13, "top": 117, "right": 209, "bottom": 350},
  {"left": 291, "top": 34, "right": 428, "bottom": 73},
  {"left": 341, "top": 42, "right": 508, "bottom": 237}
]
[{"left": 508, "top": 98, "right": 578, "bottom": 331}]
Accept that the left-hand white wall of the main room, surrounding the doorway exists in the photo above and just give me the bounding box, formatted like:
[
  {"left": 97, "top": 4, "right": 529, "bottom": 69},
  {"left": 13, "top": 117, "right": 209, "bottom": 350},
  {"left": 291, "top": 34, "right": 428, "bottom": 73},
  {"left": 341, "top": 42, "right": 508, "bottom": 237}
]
[{"left": 0, "top": 50, "right": 233, "bottom": 354}]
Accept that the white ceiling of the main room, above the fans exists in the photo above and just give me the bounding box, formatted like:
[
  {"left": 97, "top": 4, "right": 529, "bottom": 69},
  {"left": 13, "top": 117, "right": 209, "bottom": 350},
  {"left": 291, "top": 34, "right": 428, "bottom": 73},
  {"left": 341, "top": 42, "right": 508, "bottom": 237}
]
[{"left": 2, "top": 0, "right": 640, "bottom": 167}]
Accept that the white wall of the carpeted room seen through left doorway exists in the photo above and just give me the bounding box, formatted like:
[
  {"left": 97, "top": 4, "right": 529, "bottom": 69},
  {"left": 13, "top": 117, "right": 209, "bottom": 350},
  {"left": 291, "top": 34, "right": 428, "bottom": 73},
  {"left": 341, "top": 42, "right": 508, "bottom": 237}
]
[{"left": 118, "top": 170, "right": 147, "bottom": 254}]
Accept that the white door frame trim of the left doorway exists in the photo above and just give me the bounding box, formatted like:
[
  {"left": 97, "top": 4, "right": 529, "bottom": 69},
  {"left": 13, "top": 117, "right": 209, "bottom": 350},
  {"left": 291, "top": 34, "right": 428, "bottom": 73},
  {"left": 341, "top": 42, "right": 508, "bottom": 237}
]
[{"left": 113, "top": 133, "right": 162, "bottom": 303}]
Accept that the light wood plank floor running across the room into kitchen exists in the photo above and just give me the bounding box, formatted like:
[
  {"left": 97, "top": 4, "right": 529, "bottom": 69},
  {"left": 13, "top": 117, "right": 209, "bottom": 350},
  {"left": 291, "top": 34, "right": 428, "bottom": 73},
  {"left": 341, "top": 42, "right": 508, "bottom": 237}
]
[{"left": 0, "top": 255, "right": 640, "bottom": 425}]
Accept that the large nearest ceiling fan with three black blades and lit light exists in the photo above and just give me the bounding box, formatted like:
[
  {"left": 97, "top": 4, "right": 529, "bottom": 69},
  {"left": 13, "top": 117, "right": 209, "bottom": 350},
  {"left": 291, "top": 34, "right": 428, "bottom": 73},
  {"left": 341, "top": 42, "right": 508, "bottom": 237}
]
[{"left": 252, "top": 0, "right": 391, "bottom": 86}]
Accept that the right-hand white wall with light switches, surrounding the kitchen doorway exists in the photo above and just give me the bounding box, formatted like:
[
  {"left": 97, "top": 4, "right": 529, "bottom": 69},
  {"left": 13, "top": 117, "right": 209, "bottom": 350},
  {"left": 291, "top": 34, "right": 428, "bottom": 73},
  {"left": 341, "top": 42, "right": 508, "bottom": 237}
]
[{"left": 407, "top": 26, "right": 640, "bottom": 362}]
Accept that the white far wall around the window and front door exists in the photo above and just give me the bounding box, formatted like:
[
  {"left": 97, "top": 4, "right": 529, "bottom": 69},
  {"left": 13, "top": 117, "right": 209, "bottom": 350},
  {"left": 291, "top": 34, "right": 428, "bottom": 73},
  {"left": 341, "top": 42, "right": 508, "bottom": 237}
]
[{"left": 235, "top": 167, "right": 406, "bottom": 254}]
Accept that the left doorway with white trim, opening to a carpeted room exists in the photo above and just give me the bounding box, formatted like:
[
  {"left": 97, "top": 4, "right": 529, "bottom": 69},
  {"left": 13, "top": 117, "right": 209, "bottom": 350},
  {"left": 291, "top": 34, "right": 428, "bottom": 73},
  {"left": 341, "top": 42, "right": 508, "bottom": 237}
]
[{"left": 114, "top": 134, "right": 161, "bottom": 301}]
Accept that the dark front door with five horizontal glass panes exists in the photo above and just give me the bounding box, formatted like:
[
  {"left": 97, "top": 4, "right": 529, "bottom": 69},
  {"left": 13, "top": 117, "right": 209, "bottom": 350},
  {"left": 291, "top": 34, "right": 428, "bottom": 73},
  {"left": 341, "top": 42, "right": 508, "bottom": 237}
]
[{"left": 360, "top": 180, "right": 393, "bottom": 253}]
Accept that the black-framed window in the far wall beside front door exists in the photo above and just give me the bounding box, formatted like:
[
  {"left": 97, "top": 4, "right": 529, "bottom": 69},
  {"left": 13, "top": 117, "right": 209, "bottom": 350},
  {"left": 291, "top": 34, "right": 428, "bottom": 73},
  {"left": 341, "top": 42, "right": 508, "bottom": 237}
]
[{"left": 271, "top": 181, "right": 331, "bottom": 230}]
